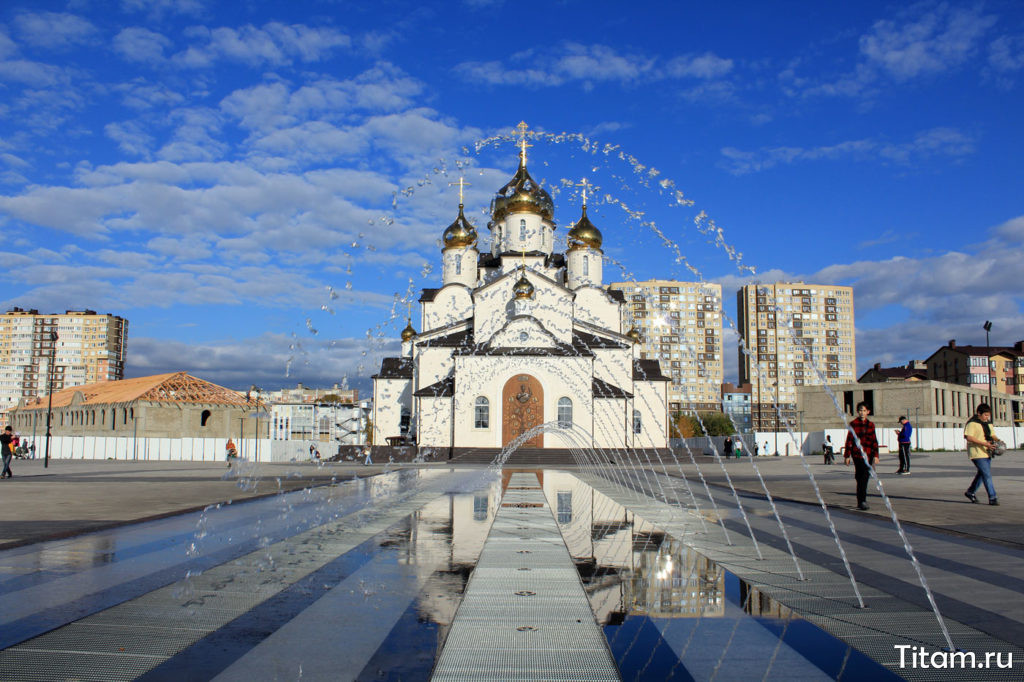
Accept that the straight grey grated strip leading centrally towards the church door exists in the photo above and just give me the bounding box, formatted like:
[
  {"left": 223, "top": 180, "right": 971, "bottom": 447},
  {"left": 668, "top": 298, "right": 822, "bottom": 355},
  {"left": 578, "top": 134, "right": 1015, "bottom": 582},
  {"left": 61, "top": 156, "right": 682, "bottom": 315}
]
[{"left": 431, "top": 473, "right": 620, "bottom": 682}]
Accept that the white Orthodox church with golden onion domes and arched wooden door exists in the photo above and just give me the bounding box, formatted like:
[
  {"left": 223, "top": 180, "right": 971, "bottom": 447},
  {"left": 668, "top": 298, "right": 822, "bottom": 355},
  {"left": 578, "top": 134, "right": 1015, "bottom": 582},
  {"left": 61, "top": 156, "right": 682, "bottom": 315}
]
[{"left": 373, "top": 134, "right": 669, "bottom": 453}]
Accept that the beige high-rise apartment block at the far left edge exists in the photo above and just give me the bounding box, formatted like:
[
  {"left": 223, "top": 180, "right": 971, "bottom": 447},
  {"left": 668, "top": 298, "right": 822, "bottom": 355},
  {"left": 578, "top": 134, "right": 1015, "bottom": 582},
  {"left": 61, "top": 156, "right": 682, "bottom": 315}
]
[{"left": 0, "top": 308, "right": 128, "bottom": 411}]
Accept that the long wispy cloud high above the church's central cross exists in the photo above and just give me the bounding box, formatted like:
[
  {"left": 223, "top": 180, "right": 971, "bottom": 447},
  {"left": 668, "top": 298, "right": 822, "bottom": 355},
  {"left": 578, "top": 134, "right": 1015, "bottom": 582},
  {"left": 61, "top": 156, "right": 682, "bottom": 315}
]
[{"left": 456, "top": 42, "right": 733, "bottom": 86}]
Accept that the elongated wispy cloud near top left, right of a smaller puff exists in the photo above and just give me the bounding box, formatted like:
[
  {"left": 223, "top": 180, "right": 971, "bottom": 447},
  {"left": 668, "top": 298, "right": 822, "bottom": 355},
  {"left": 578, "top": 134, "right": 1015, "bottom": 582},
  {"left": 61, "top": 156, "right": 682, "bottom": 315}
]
[{"left": 173, "top": 22, "right": 352, "bottom": 69}]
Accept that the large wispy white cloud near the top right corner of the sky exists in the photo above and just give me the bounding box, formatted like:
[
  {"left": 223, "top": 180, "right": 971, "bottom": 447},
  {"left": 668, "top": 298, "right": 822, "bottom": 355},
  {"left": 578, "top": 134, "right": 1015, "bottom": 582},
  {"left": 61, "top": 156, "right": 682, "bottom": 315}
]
[{"left": 860, "top": 3, "right": 996, "bottom": 81}]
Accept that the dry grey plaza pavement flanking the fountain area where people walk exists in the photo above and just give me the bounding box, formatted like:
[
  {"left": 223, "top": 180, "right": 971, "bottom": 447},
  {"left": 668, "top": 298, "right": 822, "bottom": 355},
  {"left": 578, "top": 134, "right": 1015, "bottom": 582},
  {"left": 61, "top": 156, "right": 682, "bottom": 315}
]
[{"left": 0, "top": 451, "right": 1024, "bottom": 549}]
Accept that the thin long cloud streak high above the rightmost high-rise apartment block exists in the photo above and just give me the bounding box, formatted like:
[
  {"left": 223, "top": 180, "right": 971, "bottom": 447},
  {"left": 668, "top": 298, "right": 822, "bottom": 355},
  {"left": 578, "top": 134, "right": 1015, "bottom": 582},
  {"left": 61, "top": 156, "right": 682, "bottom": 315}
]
[{"left": 719, "top": 128, "right": 975, "bottom": 175}]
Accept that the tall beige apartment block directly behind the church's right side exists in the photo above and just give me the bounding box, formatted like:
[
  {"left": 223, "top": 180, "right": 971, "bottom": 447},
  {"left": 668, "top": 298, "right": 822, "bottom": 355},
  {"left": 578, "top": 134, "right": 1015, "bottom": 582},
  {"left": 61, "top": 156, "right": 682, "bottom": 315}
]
[{"left": 609, "top": 280, "right": 724, "bottom": 412}]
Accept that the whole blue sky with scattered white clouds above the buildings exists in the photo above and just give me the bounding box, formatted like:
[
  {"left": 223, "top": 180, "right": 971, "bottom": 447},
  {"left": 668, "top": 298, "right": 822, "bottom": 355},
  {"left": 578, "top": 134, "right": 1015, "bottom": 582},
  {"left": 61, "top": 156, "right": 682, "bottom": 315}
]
[{"left": 0, "top": 0, "right": 1024, "bottom": 387}]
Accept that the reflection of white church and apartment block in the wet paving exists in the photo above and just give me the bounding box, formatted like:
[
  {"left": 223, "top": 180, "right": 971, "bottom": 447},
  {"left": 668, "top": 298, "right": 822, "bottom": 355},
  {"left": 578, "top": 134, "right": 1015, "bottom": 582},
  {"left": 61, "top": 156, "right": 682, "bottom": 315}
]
[{"left": 407, "top": 470, "right": 793, "bottom": 642}]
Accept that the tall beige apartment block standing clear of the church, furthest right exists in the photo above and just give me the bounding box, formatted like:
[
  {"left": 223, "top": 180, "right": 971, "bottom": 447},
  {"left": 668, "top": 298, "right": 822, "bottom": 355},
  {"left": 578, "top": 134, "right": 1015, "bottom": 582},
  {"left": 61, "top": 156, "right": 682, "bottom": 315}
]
[{"left": 736, "top": 282, "right": 857, "bottom": 430}]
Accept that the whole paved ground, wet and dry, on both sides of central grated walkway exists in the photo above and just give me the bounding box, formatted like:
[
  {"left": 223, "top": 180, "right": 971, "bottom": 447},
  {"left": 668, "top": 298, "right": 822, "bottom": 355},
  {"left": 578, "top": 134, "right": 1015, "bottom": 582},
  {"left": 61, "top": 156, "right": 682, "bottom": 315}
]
[{"left": 0, "top": 453, "right": 1024, "bottom": 680}]
